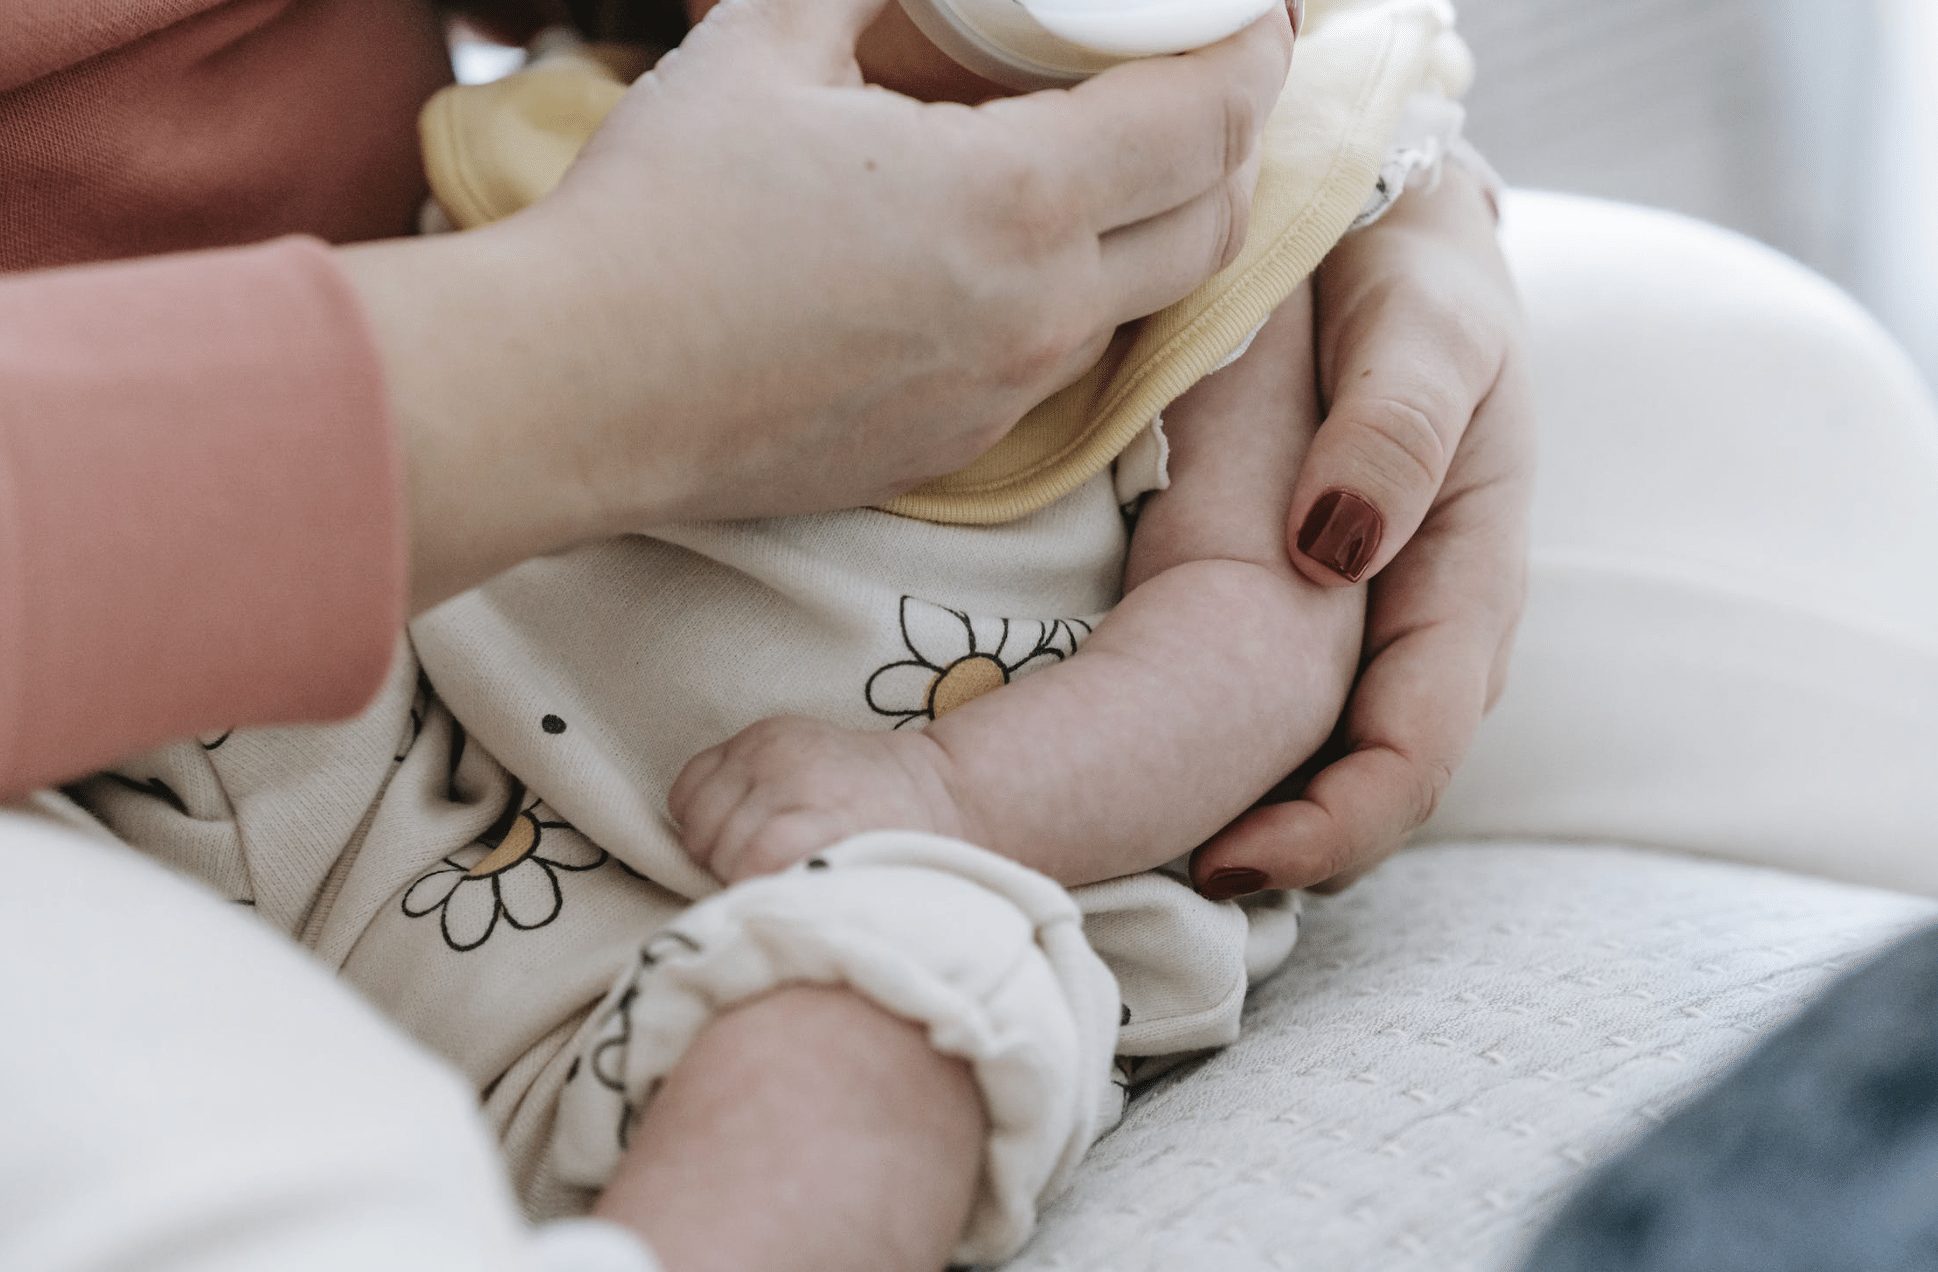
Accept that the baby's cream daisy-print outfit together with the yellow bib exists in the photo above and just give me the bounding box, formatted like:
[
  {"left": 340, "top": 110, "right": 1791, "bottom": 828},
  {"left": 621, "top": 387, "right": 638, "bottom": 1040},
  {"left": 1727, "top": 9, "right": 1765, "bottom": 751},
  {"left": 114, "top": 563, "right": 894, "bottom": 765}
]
[{"left": 74, "top": 0, "right": 1465, "bottom": 1262}]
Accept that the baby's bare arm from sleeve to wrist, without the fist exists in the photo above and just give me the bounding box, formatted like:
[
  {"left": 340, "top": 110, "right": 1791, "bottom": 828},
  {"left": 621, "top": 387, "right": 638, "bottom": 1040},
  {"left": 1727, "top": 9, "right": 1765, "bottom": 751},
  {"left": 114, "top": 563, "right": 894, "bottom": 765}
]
[{"left": 926, "top": 291, "right": 1364, "bottom": 884}]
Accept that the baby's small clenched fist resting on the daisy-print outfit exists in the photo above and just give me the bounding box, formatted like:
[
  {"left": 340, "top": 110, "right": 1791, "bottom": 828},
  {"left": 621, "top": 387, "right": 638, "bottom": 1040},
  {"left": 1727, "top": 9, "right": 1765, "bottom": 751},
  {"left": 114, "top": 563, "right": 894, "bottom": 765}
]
[{"left": 667, "top": 716, "right": 969, "bottom": 884}]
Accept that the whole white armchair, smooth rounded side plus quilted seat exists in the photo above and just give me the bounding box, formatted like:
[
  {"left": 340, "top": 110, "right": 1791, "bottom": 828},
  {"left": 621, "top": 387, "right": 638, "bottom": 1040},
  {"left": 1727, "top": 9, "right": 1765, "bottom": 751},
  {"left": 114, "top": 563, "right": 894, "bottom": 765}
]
[{"left": 1012, "top": 196, "right": 1938, "bottom": 1272}]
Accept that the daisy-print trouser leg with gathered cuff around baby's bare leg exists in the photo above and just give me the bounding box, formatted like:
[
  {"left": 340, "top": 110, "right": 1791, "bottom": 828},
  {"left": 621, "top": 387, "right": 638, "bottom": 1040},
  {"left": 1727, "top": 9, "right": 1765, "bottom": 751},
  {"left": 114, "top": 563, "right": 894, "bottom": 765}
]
[{"left": 343, "top": 810, "right": 1120, "bottom": 1262}]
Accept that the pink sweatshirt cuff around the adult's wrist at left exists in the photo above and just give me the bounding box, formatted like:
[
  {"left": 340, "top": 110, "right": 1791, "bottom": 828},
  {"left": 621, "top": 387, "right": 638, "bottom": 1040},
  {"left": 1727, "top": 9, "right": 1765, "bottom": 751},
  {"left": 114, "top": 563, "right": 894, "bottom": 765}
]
[{"left": 0, "top": 239, "right": 407, "bottom": 795}]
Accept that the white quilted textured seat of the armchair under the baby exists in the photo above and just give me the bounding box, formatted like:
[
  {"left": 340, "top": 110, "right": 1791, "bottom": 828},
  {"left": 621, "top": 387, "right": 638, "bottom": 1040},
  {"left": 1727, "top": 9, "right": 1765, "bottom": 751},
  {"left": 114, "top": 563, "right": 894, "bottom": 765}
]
[{"left": 1008, "top": 845, "right": 1938, "bottom": 1272}]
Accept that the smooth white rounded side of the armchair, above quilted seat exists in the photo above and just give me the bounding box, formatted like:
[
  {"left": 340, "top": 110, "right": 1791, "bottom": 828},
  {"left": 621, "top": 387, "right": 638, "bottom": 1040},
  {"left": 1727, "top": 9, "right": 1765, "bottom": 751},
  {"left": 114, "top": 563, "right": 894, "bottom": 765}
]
[{"left": 1428, "top": 196, "right": 1938, "bottom": 896}]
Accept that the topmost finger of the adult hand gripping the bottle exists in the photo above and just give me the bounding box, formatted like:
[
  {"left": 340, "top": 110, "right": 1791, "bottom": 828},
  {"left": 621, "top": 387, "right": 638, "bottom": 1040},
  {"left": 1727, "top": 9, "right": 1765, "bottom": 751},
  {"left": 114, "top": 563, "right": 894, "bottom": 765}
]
[{"left": 981, "top": 10, "right": 1293, "bottom": 235}]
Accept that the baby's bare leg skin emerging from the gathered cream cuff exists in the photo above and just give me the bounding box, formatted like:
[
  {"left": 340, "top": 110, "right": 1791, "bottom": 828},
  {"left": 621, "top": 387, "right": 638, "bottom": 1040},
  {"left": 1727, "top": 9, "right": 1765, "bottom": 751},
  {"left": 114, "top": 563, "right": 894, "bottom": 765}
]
[{"left": 597, "top": 987, "right": 986, "bottom": 1272}]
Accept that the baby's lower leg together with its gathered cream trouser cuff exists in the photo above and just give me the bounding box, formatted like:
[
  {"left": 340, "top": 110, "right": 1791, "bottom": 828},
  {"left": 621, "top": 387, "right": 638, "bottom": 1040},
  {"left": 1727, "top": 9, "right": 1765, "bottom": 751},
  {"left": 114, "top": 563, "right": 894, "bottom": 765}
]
[{"left": 541, "top": 834, "right": 1120, "bottom": 1272}]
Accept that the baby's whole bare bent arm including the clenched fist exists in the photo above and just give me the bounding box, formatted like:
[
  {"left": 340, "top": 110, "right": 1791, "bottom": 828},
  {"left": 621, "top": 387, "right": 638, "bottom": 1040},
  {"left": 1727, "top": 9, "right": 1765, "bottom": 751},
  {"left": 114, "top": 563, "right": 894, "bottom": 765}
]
[{"left": 672, "top": 291, "right": 1364, "bottom": 886}]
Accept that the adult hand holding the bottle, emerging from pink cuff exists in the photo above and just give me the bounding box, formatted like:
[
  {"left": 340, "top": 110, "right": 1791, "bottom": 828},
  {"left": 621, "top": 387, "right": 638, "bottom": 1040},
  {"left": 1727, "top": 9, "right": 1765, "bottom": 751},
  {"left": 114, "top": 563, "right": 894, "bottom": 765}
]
[{"left": 349, "top": 0, "right": 1291, "bottom": 603}]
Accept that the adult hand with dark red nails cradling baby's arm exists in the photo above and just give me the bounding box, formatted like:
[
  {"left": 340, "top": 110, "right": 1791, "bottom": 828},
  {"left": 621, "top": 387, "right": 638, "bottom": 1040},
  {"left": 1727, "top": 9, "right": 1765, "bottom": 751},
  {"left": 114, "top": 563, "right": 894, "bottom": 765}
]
[{"left": 1192, "top": 169, "right": 1535, "bottom": 896}]
